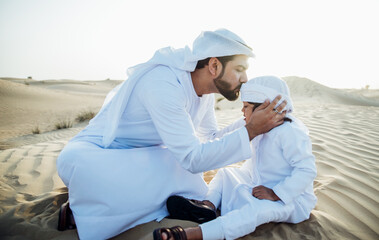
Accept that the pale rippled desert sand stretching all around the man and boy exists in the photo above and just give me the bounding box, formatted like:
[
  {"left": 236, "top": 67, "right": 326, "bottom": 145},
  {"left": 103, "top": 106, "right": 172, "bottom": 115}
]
[{"left": 0, "top": 77, "right": 379, "bottom": 239}]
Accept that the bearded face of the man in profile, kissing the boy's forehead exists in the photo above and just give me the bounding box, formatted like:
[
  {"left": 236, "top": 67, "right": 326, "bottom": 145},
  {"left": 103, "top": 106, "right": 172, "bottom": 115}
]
[{"left": 213, "top": 55, "right": 249, "bottom": 101}]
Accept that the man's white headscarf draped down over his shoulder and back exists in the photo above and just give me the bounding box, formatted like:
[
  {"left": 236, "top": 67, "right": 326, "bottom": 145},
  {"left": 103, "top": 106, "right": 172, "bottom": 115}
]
[{"left": 100, "top": 29, "right": 254, "bottom": 148}]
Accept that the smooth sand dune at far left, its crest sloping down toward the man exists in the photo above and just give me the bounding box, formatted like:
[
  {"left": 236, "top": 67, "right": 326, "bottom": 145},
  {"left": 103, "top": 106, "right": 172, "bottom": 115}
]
[{"left": 0, "top": 80, "right": 106, "bottom": 145}]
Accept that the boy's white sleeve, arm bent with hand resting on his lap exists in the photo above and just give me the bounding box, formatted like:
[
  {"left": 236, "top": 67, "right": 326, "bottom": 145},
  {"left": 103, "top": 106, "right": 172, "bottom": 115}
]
[{"left": 272, "top": 125, "right": 317, "bottom": 204}]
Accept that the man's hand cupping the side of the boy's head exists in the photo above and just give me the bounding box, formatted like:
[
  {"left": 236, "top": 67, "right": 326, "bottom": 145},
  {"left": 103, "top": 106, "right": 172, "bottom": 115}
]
[{"left": 245, "top": 95, "right": 287, "bottom": 140}]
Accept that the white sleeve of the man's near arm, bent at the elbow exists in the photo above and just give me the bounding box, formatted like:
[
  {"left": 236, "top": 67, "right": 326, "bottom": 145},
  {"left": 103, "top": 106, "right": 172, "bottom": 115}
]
[{"left": 141, "top": 74, "right": 251, "bottom": 173}]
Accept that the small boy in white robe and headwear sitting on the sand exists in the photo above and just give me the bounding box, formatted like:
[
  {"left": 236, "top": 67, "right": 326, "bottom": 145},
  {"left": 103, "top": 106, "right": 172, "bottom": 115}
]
[{"left": 154, "top": 76, "right": 317, "bottom": 239}]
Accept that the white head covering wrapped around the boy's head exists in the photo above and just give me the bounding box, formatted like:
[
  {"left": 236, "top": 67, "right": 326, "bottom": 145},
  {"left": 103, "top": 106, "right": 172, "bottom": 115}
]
[{"left": 241, "top": 76, "right": 294, "bottom": 113}]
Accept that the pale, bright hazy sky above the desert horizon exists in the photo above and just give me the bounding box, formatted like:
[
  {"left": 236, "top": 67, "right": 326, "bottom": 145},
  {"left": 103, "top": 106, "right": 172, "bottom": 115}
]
[{"left": 0, "top": 0, "right": 379, "bottom": 88}]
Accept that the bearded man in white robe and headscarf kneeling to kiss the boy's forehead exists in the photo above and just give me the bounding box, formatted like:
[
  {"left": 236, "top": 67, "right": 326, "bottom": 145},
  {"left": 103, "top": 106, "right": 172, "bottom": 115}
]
[{"left": 57, "top": 29, "right": 285, "bottom": 239}]
